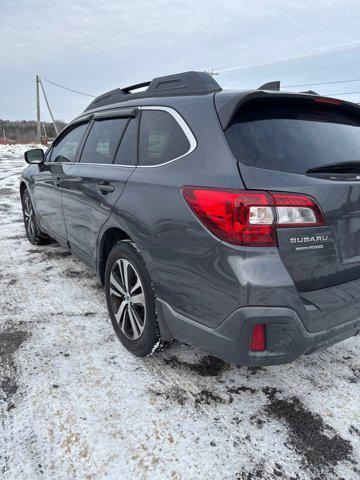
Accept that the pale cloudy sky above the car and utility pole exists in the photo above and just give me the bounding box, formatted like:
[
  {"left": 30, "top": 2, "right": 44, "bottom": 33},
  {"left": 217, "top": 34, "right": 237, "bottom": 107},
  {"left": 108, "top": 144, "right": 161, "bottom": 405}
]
[{"left": 0, "top": 0, "right": 360, "bottom": 121}]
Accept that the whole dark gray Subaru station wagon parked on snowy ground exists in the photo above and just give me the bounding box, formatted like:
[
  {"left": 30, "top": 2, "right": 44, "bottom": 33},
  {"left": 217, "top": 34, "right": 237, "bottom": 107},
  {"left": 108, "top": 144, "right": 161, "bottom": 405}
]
[{"left": 20, "top": 72, "right": 360, "bottom": 365}]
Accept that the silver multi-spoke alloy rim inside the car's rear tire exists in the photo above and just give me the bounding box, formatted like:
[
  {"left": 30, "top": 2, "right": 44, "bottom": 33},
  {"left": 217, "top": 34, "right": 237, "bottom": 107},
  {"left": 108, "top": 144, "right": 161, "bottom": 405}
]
[{"left": 110, "top": 258, "right": 146, "bottom": 340}]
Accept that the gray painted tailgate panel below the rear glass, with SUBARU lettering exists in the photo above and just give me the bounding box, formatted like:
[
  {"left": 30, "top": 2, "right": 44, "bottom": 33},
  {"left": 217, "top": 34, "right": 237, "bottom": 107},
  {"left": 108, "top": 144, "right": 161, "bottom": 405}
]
[{"left": 241, "top": 165, "right": 360, "bottom": 291}]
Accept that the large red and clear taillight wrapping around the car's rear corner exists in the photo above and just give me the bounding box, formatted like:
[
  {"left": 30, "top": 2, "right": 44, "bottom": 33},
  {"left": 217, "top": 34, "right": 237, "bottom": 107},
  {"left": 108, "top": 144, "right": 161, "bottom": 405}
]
[{"left": 182, "top": 187, "right": 325, "bottom": 247}]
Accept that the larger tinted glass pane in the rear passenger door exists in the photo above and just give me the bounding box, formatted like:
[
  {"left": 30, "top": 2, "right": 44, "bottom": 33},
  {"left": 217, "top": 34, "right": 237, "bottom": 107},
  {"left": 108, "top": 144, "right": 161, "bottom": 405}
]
[{"left": 80, "top": 118, "right": 128, "bottom": 164}]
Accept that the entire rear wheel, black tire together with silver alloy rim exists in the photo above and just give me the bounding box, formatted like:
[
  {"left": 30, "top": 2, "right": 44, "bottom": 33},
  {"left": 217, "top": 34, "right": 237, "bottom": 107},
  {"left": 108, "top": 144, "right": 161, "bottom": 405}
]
[{"left": 105, "top": 240, "right": 163, "bottom": 357}]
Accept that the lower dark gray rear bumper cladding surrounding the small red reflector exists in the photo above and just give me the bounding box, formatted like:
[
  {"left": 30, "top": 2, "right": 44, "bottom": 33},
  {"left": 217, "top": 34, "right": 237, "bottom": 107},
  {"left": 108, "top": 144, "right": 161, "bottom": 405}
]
[{"left": 156, "top": 299, "right": 360, "bottom": 366}]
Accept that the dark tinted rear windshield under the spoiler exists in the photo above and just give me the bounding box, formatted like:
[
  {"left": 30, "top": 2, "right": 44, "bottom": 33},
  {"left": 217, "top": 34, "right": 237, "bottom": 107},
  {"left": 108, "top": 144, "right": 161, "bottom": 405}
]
[{"left": 225, "top": 99, "right": 360, "bottom": 174}]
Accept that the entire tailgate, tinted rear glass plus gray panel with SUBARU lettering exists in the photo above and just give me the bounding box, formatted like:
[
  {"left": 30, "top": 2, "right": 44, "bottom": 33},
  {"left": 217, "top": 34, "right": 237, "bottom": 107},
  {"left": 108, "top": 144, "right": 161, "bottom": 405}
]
[{"left": 226, "top": 97, "right": 360, "bottom": 291}]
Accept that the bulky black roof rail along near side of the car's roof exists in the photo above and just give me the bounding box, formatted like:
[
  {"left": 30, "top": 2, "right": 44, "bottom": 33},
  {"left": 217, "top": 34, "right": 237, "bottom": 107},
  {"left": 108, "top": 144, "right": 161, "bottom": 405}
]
[{"left": 85, "top": 71, "right": 222, "bottom": 112}]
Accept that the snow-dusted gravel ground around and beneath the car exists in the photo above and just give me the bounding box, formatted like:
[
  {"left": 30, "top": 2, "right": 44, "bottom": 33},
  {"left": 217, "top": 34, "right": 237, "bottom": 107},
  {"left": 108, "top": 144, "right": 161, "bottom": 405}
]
[{"left": 0, "top": 146, "right": 360, "bottom": 480}]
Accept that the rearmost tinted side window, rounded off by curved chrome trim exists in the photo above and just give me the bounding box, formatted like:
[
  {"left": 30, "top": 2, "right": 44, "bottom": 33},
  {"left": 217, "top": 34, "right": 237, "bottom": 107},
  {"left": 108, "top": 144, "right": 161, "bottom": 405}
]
[{"left": 139, "top": 110, "right": 190, "bottom": 165}]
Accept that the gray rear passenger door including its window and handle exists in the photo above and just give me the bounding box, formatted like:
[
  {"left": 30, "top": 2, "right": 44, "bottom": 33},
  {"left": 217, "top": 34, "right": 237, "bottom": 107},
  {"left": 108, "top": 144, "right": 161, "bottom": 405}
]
[{"left": 63, "top": 111, "right": 137, "bottom": 259}]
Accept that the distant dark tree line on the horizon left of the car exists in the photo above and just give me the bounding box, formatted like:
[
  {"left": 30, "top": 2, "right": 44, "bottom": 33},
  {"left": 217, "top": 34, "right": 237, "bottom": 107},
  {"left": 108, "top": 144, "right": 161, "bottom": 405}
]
[{"left": 0, "top": 119, "right": 66, "bottom": 143}]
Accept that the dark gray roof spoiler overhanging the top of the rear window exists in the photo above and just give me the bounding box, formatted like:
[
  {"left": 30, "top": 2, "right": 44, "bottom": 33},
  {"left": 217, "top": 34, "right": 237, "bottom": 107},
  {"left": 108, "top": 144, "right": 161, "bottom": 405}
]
[{"left": 215, "top": 90, "right": 360, "bottom": 130}]
